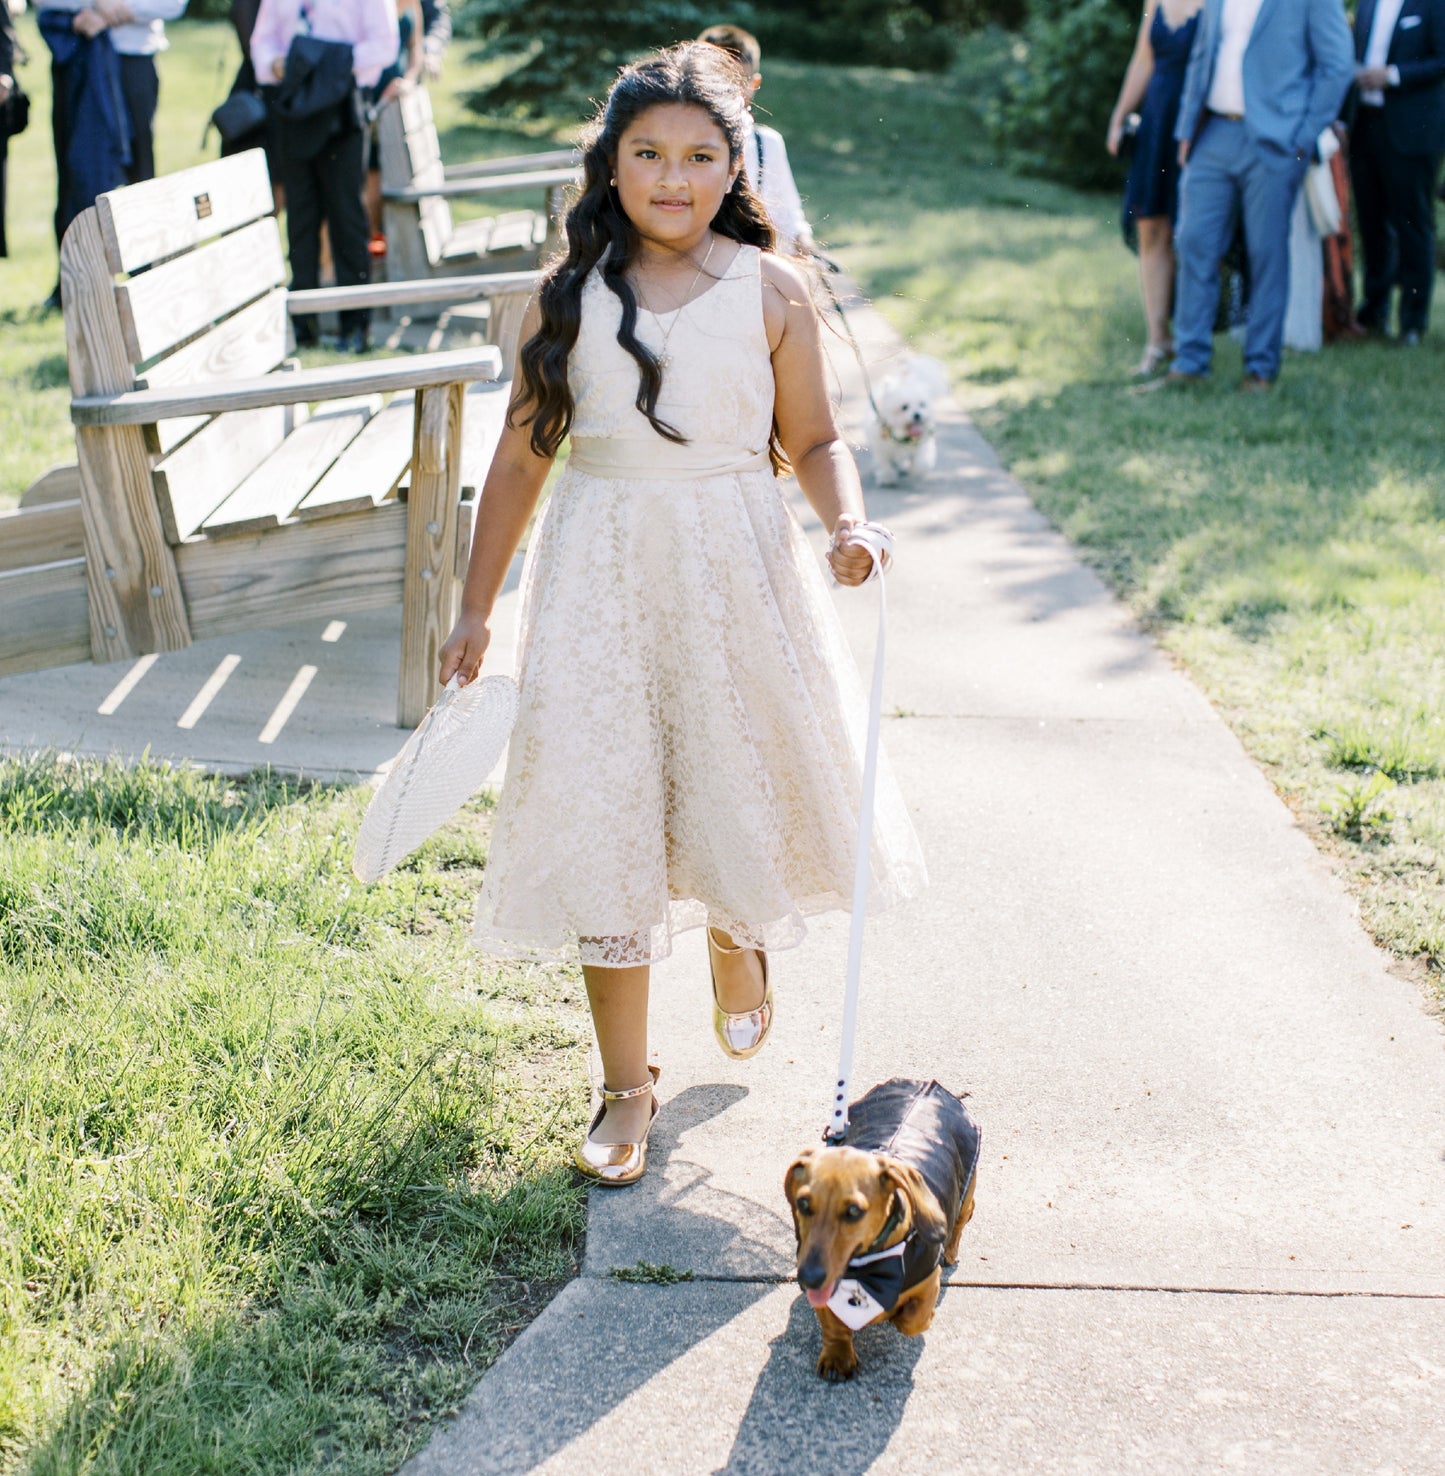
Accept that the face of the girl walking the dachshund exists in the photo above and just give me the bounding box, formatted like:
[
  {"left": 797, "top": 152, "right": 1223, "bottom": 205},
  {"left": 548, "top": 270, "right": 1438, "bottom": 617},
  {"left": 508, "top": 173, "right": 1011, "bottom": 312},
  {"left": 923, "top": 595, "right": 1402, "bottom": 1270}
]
[{"left": 614, "top": 102, "right": 738, "bottom": 249}]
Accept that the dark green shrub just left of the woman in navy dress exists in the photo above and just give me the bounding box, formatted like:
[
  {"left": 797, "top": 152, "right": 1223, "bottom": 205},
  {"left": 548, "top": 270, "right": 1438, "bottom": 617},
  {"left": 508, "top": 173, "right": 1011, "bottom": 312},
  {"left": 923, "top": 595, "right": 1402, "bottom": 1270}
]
[{"left": 989, "top": 0, "right": 1139, "bottom": 189}]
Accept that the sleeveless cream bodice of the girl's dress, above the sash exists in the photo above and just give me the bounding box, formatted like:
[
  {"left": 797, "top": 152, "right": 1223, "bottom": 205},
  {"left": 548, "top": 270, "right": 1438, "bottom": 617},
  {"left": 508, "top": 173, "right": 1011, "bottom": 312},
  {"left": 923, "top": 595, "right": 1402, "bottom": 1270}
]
[{"left": 567, "top": 242, "right": 773, "bottom": 452}]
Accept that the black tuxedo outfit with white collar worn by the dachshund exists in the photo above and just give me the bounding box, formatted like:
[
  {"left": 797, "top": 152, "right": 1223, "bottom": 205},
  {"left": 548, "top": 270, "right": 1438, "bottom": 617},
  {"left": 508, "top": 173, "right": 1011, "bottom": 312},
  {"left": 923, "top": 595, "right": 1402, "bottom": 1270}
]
[{"left": 828, "top": 1079, "right": 982, "bottom": 1331}]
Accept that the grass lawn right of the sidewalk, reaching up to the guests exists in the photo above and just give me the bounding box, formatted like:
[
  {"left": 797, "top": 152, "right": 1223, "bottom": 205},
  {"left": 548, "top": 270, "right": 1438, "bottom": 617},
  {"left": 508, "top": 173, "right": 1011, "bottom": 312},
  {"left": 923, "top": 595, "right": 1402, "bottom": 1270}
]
[{"left": 762, "top": 52, "right": 1445, "bottom": 984}]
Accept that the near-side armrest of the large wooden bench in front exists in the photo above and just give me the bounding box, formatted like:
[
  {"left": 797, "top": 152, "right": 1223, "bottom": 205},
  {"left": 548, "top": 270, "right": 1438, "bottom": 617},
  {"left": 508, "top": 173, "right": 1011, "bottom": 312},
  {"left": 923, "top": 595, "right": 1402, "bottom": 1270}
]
[{"left": 71, "top": 344, "right": 502, "bottom": 425}]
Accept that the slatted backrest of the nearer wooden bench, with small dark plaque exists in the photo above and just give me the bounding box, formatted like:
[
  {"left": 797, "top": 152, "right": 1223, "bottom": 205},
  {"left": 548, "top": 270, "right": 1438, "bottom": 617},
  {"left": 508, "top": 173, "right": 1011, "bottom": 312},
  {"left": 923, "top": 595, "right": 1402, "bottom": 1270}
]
[{"left": 65, "top": 149, "right": 289, "bottom": 543}]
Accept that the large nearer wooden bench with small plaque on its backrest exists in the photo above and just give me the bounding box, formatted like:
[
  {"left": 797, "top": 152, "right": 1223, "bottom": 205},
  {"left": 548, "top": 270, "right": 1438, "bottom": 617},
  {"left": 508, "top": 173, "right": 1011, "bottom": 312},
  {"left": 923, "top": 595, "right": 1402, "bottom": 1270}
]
[{"left": 0, "top": 151, "right": 534, "bottom": 726}]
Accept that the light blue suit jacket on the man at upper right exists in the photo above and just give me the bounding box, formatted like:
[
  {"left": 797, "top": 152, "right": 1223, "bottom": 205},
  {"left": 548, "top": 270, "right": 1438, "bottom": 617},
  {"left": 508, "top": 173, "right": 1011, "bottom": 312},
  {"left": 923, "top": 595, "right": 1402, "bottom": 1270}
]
[{"left": 1175, "top": 0, "right": 1355, "bottom": 154}]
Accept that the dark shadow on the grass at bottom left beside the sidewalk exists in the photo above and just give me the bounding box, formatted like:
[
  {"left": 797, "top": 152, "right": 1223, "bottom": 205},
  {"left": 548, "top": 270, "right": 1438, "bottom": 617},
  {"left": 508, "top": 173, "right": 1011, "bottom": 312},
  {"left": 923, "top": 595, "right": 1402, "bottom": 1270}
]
[{"left": 27, "top": 1170, "right": 571, "bottom": 1476}]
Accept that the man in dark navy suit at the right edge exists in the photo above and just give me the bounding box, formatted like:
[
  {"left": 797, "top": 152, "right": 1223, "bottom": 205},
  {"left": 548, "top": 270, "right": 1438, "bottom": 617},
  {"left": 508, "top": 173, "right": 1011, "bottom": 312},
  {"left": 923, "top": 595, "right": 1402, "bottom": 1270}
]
[{"left": 1349, "top": 0, "right": 1445, "bottom": 344}]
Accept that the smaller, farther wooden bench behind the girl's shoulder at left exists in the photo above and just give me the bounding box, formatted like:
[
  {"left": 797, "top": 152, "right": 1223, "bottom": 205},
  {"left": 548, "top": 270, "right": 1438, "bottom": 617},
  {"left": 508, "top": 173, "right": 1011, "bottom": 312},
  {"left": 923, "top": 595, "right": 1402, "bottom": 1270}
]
[{"left": 378, "top": 87, "right": 579, "bottom": 296}]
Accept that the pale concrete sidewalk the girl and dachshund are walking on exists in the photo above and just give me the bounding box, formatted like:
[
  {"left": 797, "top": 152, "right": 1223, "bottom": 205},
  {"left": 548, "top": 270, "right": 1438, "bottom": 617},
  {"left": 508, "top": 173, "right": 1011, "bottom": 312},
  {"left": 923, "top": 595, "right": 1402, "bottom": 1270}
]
[{"left": 407, "top": 293, "right": 1445, "bottom": 1476}]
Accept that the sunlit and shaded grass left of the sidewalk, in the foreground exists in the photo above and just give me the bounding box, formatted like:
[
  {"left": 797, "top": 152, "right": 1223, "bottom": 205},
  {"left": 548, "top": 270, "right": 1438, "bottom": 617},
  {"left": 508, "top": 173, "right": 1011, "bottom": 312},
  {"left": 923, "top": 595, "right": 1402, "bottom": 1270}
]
[{"left": 0, "top": 759, "right": 586, "bottom": 1476}]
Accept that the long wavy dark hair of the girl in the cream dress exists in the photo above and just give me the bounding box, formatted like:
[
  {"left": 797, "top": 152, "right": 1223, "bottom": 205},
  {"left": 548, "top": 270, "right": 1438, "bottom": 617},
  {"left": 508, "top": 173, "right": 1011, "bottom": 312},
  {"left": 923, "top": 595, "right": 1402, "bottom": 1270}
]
[{"left": 518, "top": 41, "right": 778, "bottom": 465}]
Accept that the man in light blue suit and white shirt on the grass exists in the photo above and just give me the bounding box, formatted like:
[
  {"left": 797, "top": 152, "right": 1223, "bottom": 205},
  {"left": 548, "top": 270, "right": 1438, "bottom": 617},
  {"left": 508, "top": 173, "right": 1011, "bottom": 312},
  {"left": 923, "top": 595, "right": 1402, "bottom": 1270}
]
[{"left": 1168, "top": 0, "right": 1355, "bottom": 390}]
